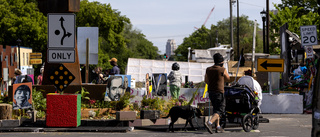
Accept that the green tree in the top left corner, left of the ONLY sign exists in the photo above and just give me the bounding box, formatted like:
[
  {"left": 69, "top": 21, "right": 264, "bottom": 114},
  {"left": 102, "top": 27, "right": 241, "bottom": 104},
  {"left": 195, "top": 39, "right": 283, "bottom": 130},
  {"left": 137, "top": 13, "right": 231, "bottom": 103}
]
[{"left": 0, "top": 0, "right": 47, "bottom": 53}]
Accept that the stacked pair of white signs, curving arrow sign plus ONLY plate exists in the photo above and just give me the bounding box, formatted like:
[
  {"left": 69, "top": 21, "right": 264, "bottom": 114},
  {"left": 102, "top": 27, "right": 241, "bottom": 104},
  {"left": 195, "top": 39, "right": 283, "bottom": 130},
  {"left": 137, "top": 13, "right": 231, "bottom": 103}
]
[{"left": 47, "top": 13, "right": 75, "bottom": 63}]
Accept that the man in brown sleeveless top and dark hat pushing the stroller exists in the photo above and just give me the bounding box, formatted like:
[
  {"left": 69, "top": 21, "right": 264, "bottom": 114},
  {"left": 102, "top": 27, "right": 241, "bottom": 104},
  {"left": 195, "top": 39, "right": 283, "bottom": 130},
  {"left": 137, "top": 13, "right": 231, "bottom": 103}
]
[{"left": 204, "top": 53, "right": 230, "bottom": 134}]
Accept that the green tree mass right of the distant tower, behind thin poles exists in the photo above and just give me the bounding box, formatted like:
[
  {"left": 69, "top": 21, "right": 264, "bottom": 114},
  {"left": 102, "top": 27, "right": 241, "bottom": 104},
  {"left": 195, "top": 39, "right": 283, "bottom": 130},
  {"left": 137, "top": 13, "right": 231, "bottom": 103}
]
[{"left": 175, "top": 15, "right": 263, "bottom": 61}]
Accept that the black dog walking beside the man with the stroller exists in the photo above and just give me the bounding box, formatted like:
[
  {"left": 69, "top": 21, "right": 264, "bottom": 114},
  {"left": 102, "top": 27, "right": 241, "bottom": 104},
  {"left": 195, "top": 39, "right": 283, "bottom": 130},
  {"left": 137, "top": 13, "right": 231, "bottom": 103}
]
[{"left": 164, "top": 106, "right": 201, "bottom": 132}]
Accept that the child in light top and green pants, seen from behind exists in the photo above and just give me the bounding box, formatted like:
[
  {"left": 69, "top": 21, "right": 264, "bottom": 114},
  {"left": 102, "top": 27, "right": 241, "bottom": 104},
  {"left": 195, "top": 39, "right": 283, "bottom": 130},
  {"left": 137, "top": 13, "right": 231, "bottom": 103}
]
[{"left": 168, "top": 62, "right": 182, "bottom": 99}]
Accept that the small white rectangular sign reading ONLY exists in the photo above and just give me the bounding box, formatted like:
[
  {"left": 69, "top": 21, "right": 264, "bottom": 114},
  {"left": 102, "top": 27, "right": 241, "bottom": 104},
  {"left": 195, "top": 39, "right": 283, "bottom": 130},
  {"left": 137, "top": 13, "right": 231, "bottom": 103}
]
[{"left": 47, "top": 49, "right": 75, "bottom": 63}]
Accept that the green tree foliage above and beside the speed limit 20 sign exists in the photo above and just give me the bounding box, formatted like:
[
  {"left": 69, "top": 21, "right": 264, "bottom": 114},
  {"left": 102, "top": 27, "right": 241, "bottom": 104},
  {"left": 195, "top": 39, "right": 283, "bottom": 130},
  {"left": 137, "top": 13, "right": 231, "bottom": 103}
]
[{"left": 270, "top": 5, "right": 320, "bottom": 54}]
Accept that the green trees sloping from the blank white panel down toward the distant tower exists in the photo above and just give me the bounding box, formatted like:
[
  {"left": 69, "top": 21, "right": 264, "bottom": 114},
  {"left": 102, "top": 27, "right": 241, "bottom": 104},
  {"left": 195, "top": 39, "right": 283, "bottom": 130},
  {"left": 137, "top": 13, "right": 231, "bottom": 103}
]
[{"left": 76, "top": 0, "right": 158, "bottom": 74}]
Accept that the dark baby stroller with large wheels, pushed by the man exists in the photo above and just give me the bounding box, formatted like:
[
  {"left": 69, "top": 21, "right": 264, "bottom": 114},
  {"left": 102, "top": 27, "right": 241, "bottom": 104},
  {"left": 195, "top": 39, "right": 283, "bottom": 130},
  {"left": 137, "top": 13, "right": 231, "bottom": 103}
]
[{"left": 220, "top": 84, "right": 260, "bottom": 132}]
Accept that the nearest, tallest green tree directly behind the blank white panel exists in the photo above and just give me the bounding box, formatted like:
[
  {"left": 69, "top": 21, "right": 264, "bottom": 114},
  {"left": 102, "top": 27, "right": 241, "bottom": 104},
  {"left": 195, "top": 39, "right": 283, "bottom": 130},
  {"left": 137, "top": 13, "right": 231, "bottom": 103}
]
[{"left": 76, "top": 0, "right": 130, "bottom": 73}]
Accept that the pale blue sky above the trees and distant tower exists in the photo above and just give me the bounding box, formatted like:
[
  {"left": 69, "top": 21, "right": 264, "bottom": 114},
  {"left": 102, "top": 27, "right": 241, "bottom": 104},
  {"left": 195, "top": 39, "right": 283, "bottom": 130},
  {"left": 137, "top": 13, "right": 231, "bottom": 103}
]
[{"left": 89, "top": 0, "right": 281, "bottom": 54}]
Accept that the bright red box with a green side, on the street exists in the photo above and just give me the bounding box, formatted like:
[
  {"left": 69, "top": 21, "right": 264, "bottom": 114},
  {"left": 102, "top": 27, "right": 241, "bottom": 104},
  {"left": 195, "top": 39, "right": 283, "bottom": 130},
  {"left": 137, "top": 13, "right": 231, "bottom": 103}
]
[{"left": 46, "top": 94, "right": 81, "bottom": 127}]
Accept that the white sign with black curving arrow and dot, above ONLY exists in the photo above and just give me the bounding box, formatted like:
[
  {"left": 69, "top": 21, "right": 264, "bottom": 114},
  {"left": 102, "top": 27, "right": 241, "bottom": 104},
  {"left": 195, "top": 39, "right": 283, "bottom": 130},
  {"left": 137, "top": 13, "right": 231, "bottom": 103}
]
[{"left": 48, "top": 13, "right": 75, "bottom": 49}]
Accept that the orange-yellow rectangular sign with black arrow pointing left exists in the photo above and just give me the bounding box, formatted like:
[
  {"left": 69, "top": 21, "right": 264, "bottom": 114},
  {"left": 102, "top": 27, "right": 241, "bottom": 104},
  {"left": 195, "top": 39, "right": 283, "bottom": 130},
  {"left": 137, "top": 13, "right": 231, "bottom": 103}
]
[{"left": 258, "top": 58, "right": 284, "bottom": 72}]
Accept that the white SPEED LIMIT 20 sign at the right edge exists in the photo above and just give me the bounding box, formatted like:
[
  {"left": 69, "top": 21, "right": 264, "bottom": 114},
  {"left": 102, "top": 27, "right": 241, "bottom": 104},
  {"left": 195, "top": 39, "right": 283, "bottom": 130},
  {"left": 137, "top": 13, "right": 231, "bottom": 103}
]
[{"left": 300, "top": 25, "right": 318, "bottom": 46}]
